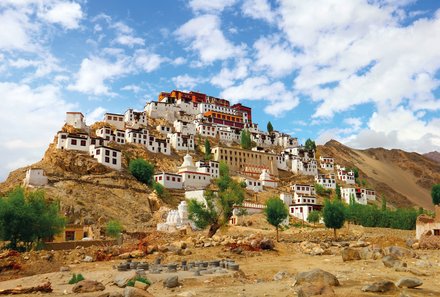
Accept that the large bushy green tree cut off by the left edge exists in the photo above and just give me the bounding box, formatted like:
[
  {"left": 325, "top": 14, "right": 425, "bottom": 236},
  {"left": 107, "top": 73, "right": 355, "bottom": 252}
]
[{"left": 0, "top": 188, "right": 66, "bottom": 250}]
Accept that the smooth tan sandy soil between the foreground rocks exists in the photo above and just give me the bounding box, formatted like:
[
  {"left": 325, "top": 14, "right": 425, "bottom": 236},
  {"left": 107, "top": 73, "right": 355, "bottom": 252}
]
[{"left": 0, "top": 226, "right": 440, "bottom": 297}]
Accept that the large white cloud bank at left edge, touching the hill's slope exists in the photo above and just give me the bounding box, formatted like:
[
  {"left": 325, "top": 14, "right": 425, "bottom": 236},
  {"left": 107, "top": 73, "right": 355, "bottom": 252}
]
[{"left": 0, "top": 82, "right": 75, "bottom": 180}]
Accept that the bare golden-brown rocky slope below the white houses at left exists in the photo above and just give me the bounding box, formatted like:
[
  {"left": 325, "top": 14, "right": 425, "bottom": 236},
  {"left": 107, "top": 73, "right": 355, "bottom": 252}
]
[{"left": 0, "top": 140, "right": 187, "bottom": 231}]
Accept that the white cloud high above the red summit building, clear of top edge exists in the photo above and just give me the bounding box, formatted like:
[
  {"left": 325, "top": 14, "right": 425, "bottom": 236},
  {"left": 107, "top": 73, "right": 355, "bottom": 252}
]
[{"left": 174, "top": 14, "right": 244, "bottom": 64}]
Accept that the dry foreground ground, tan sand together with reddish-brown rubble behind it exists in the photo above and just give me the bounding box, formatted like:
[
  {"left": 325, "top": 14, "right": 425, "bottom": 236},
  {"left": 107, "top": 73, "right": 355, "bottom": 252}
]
[{"left": 0, "top": 222, "right": 440, "bottom": 297}]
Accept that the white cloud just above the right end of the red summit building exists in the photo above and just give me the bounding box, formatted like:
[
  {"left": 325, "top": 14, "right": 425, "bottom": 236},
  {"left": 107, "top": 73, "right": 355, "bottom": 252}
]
[{"left": 220, "top": 76, "right": 299, "bottom": 116}]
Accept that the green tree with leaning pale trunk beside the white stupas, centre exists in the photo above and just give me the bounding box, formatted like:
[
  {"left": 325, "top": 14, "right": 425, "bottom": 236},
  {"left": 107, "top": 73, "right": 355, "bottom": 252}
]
[{"left": 188, "top": 162, "right": 245, "bottom": 237}]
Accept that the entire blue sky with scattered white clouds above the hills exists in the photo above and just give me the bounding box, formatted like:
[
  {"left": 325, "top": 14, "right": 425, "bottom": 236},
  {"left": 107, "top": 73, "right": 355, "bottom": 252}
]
[{"left": 0, "top": 0, "right": 440, "bottom": 180}]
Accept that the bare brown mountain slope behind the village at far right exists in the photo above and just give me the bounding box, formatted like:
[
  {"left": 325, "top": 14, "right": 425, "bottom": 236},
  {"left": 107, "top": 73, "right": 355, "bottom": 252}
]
[{"left": 318, "top": 140, "right": 440, "bottom": 209}]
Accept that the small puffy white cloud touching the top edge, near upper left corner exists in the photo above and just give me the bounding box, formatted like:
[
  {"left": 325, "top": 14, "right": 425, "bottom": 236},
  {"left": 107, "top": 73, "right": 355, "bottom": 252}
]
[{"left": 41, "top": 1, "right": 84, "bottom": 29}]
